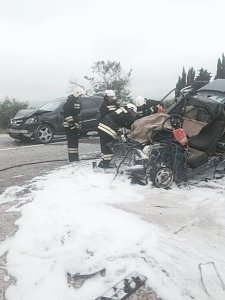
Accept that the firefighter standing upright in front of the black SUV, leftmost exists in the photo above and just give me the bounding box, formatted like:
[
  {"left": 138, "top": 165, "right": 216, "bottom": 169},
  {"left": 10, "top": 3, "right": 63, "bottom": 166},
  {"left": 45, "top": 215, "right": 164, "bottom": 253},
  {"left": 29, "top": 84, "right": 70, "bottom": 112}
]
[{"left": 63, "top": 87, "right": 86, "bottom": 162}]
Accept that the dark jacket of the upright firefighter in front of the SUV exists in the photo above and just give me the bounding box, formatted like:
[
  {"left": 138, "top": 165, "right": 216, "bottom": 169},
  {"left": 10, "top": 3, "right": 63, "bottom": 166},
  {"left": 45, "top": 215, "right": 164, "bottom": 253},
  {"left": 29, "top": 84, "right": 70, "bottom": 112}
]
[{"left": 63, "top": 95, "right": 80, "bottom": 129}]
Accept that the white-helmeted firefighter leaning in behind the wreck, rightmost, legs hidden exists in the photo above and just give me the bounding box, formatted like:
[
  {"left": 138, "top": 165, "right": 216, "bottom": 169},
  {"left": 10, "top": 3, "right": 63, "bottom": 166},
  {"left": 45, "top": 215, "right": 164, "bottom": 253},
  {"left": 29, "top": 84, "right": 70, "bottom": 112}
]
[{"left": 133, "top": 96, "right": 164, "bottom": 119}]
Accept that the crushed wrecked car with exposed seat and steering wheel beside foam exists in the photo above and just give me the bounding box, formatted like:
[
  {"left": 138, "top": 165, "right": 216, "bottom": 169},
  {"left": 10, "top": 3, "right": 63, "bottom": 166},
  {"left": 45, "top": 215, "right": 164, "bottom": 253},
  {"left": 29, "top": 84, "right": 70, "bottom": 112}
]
[{"left": 113, "top": 80, "right": 225, "bottom": 188}]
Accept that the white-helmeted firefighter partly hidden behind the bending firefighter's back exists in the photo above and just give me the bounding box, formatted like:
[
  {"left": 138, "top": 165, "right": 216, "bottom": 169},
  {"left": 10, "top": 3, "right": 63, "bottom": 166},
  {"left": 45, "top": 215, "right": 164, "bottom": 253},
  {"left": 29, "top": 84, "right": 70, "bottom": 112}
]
[{"left": 100, "top": 90, "right": 120, "bottom": 120}]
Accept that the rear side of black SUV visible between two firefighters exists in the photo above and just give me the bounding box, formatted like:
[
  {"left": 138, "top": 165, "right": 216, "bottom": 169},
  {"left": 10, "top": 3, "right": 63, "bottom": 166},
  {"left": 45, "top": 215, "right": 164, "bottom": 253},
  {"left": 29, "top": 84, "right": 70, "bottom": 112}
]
[{"left": 79, "top": 97, "right": 103, "bottom": 132}]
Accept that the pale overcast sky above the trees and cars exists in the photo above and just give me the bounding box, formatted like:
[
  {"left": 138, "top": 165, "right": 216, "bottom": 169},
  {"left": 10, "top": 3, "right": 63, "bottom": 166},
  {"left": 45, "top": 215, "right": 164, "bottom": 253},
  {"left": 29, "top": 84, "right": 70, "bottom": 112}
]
[{"left": 0, "top": 0, "right": 225, "bottom": 102}]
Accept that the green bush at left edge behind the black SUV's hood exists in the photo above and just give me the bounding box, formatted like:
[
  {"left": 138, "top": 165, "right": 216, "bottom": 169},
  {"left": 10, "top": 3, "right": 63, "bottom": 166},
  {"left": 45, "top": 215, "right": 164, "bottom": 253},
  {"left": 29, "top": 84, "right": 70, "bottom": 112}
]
[{"left": 0, "top": 97, "right": 29, "bottom": 129}]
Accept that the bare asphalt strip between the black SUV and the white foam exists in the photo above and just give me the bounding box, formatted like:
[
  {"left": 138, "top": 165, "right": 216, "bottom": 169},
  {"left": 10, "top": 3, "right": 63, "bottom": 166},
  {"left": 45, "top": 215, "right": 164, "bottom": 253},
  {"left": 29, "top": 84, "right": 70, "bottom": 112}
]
[{"left": 0, "top": 135, "right": 100, "bottom": 194}]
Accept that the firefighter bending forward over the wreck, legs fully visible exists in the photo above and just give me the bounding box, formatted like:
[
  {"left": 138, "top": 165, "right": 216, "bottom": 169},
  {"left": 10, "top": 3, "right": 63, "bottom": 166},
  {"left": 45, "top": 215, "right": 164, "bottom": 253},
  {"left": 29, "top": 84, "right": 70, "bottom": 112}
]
[{"left": 98, "top": 103, "right": 137, "bottom": 168}]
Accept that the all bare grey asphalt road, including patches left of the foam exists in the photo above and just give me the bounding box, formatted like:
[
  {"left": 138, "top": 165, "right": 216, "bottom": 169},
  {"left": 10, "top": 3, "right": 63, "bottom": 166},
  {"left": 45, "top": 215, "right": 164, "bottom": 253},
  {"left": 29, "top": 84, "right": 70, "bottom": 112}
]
[{"left": 0, "top": 134, "right": 100, "bottom": 300}]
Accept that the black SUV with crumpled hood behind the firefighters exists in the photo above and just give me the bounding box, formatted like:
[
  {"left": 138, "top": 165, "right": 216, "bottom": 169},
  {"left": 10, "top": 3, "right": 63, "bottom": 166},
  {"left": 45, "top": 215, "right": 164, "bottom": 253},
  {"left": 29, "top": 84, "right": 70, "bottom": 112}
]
[{"left": 8, "top": 96, "right": 103, "bottom": 144}]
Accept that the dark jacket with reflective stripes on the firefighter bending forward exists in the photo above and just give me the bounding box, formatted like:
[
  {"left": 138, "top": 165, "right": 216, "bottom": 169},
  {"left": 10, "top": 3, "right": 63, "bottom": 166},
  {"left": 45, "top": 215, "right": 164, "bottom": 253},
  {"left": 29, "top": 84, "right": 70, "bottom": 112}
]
[{"left": 98, "top": 107, "right": 136, "bottom": 139}]
